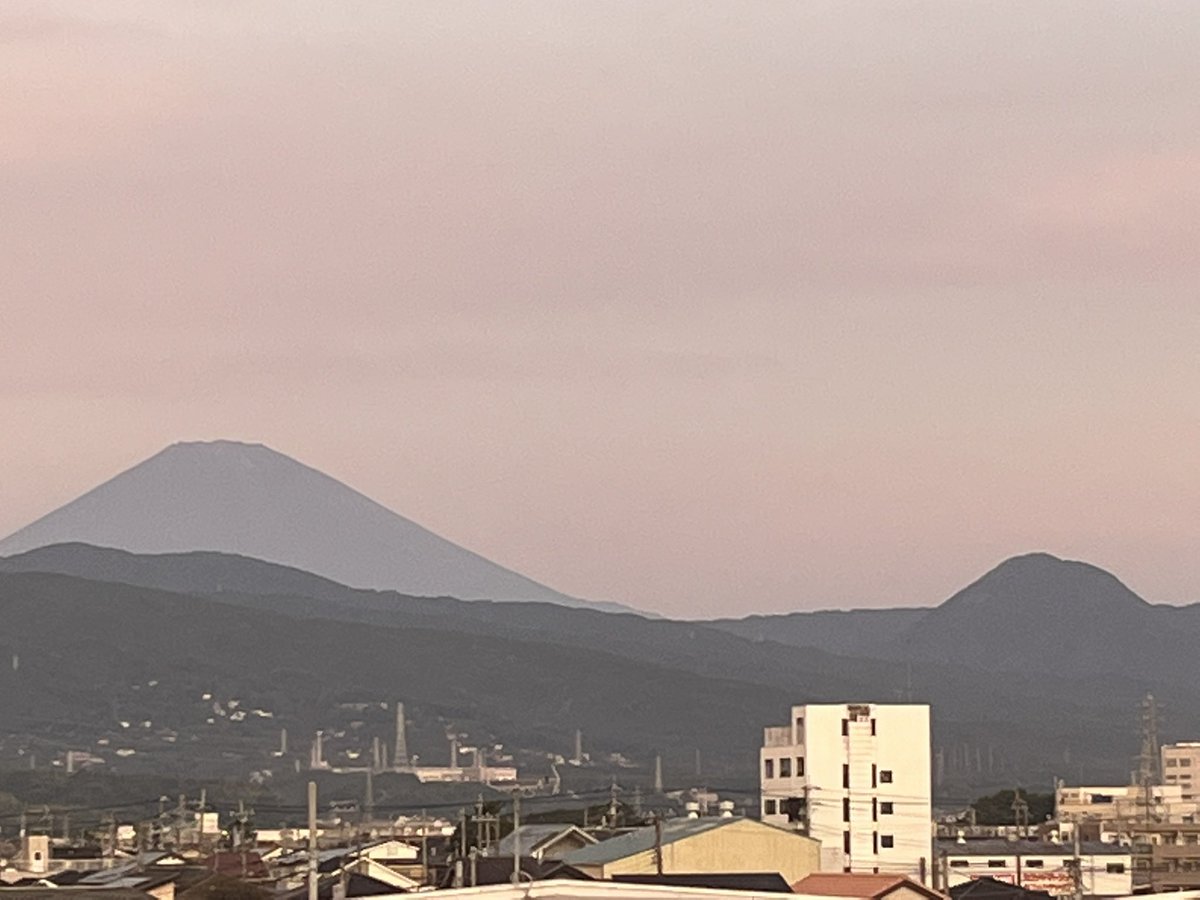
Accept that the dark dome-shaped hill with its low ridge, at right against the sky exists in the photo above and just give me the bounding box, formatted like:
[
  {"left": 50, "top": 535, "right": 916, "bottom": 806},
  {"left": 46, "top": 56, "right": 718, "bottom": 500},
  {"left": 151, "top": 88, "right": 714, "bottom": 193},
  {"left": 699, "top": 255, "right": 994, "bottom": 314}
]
[{"left": 708, "top": 553, "right": 1200, "bottom": 682}]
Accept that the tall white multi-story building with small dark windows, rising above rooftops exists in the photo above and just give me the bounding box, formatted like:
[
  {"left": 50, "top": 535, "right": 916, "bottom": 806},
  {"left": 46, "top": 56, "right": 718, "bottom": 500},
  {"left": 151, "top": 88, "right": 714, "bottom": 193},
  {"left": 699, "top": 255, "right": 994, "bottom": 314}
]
[{"left": 758, "top": 703, "right": 934, "bottom": 883}]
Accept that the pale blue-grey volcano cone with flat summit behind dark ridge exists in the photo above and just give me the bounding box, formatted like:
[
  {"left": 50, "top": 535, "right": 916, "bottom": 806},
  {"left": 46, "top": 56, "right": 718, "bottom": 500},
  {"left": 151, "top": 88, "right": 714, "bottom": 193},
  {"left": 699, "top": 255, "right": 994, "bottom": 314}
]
[{"left": 0, "top": 440, "right": 638, "bottom": 608}]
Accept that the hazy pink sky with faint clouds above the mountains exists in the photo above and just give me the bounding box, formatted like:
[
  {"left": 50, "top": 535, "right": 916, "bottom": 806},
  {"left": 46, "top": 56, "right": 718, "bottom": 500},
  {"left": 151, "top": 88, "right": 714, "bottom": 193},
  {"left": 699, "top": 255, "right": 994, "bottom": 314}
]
[{"left": 0, "top": 0, "right": 1200, "bottom": 616}]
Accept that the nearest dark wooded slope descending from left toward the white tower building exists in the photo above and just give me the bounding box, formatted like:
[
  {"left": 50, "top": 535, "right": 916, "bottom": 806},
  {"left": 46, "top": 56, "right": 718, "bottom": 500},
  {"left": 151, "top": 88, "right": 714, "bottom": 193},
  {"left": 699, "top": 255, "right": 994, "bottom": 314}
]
[{"left": 0, "top": 574, "right": 787, "bottom": 770}]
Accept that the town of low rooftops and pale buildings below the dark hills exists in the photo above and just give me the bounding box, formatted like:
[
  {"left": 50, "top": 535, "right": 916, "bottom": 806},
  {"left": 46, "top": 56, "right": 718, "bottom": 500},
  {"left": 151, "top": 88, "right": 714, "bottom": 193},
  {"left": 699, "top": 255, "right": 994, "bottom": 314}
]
[{"left": 0, "top": 697, "right": 1200, "bottom": 900}]
